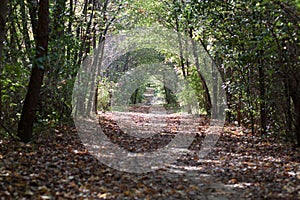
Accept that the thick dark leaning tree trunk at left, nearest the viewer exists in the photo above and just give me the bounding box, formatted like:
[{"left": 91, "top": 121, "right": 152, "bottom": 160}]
[{"left": 17, "top": 0, "right": 49, "bottom": 142}]
